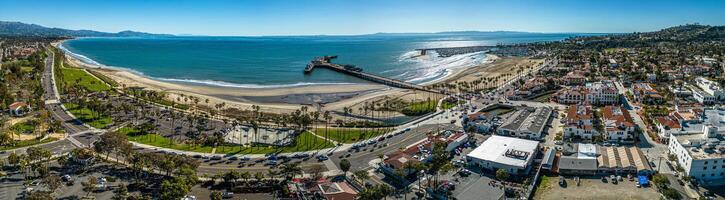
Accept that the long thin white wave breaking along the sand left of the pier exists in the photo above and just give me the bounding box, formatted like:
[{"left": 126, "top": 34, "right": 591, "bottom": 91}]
[{"left": 153, "top": 78, "right": 355, "bottom": 89}]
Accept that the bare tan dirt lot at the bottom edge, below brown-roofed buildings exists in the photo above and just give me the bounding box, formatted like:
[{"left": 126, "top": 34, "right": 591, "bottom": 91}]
[{"left": 534, "top": 176, "right": 660, "bottom": 199}]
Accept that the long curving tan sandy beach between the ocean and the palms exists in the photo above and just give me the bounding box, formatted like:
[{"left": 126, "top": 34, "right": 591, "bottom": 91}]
[{"left": 54, "top": 40, "right": 498, "bottom": 113}]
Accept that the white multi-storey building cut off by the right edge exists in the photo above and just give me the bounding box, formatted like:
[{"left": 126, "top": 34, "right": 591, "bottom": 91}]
[{"left": 668, "top": 125, "right": 725, "bottom": 185}]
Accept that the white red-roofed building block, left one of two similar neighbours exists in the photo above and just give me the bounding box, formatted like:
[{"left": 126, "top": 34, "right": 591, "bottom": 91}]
[{"left": 564, "top": 105, "right": 599, "bottom": 140}]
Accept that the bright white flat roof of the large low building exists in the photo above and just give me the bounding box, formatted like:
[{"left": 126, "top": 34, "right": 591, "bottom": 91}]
[{"left": 466, "top": 135, "right": 539, "bottom": 168}]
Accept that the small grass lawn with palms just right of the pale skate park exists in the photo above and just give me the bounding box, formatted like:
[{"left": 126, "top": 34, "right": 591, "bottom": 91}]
[{"left": 314, "top": 128, "right": 391, "bottom": 143}]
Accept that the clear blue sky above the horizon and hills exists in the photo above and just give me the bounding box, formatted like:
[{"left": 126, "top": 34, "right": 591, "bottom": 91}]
[{"left": 0, "top": 0, "right": 725, "bottom": 35}]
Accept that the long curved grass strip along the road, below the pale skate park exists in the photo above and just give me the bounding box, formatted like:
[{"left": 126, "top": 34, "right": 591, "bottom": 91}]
[{"left": 119, "top": 127, "right": 335, "bottom": 154}]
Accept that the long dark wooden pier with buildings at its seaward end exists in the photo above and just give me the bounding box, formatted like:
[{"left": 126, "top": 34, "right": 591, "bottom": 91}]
[{"left": 305, "top": 56, "right": 442, "bottom": 93}]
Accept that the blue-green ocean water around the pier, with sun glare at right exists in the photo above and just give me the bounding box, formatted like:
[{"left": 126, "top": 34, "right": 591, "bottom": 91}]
[{"left": 61, "top": 32, "right": 588, "bottom": 88}]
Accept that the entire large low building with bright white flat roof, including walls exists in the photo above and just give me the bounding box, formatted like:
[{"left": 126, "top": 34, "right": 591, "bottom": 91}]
[{"left": 466, "top": 135, "right": 539, "bottom": 174}]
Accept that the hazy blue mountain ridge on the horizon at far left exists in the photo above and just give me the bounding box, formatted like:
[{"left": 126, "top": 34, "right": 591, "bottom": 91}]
[{"left": 0, "top": 21, "right": 174, "bottom": 37}]
